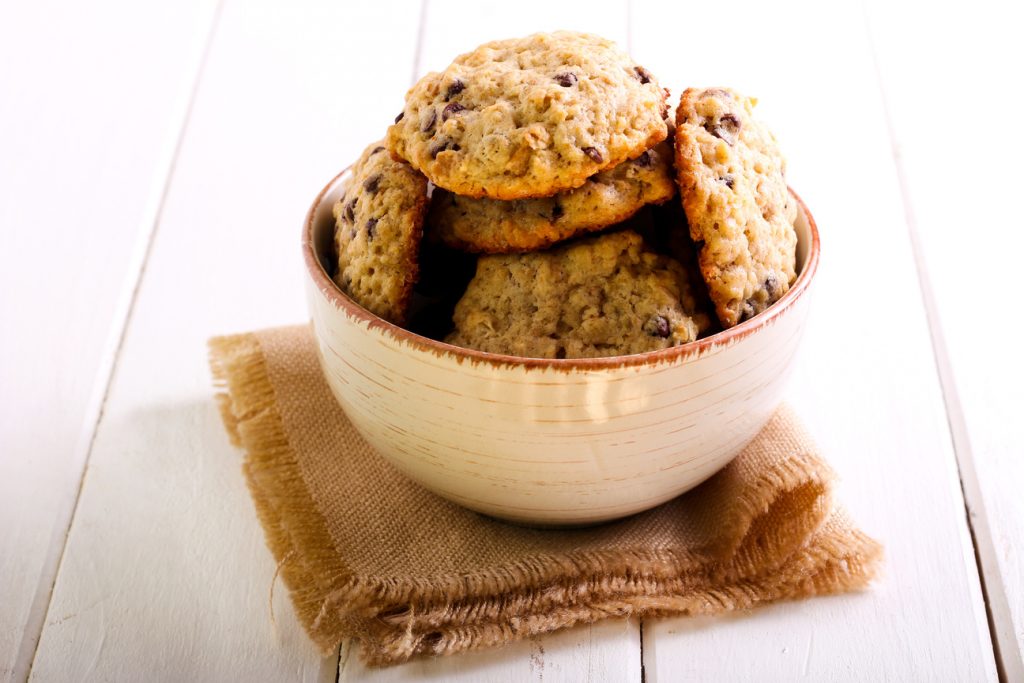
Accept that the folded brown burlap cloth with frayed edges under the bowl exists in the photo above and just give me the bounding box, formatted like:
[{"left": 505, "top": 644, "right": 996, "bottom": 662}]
[{"left": 205, "top": 326, "right": 882, "bottom": 665}]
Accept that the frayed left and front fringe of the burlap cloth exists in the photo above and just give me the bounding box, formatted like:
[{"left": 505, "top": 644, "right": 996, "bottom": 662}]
[{"left": 210, "top": 334, "right": 881, "bottom": 666}]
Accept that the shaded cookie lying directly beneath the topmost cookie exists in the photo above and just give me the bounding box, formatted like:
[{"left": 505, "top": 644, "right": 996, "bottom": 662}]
[{"left": 427, "top": 140, "right": 676, "bottom": 254}]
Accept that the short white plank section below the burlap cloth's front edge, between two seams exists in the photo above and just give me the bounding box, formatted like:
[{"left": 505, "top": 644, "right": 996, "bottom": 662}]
[{"left": 338, "top": 620, "right": 641, "bottom": 683}]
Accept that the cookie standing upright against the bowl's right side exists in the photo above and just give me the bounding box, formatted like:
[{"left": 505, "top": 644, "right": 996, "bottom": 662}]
[{"left": 676, "top": 88, "right": 797, "bottom": 328}]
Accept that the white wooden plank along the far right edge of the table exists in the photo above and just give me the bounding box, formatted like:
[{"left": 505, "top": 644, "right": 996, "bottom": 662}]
[{"left": 868, "top": 2, "right": 1024, "bottom": 681}]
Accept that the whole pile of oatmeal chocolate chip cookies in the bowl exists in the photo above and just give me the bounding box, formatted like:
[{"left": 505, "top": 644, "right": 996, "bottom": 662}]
[{"left": 334, "top": 32, "right": 796, "bottom": 358}]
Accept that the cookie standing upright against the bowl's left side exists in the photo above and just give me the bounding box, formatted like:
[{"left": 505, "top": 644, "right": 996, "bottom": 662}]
[{"left": 334, "top": 142, "right": 427, "bottom": 325}]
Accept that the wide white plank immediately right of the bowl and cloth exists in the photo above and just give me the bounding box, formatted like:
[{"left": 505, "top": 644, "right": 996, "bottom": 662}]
[{"left": 631, "top": 2, "right": 995, "bottom": 681}]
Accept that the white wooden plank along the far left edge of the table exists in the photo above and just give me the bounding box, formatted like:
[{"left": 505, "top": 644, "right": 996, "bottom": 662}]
[{"left": 0, "top": 0, "right": 213, "bottom": 680}]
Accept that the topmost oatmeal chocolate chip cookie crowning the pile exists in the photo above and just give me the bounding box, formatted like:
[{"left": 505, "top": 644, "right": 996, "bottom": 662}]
[{"left": 387, "top": 31, "right": 668, "bottom": 200}]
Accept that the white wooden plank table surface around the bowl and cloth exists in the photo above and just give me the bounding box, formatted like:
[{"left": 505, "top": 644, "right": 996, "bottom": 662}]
[{"left": 0, "top": 0, "right": 1024, "bottom": 681}]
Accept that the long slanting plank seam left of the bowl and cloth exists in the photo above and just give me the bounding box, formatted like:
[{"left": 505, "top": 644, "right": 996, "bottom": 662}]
[{"left": 17, "top": 0, "right": 223, "bottom": 681}]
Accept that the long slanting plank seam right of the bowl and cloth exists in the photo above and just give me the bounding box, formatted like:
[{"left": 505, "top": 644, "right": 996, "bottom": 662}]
[{"left": 864, "top": 4, "right": 1007, "bottom": 682}]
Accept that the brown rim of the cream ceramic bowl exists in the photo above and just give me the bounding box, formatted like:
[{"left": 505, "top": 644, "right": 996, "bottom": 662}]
[{"left": 302, "top": 168, "right": 821, "bottom": 372}]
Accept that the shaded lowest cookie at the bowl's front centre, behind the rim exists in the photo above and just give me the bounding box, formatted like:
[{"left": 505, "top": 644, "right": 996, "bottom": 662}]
[{"left": 445, "top": 230, "right": 708, "bottom": 358}]
